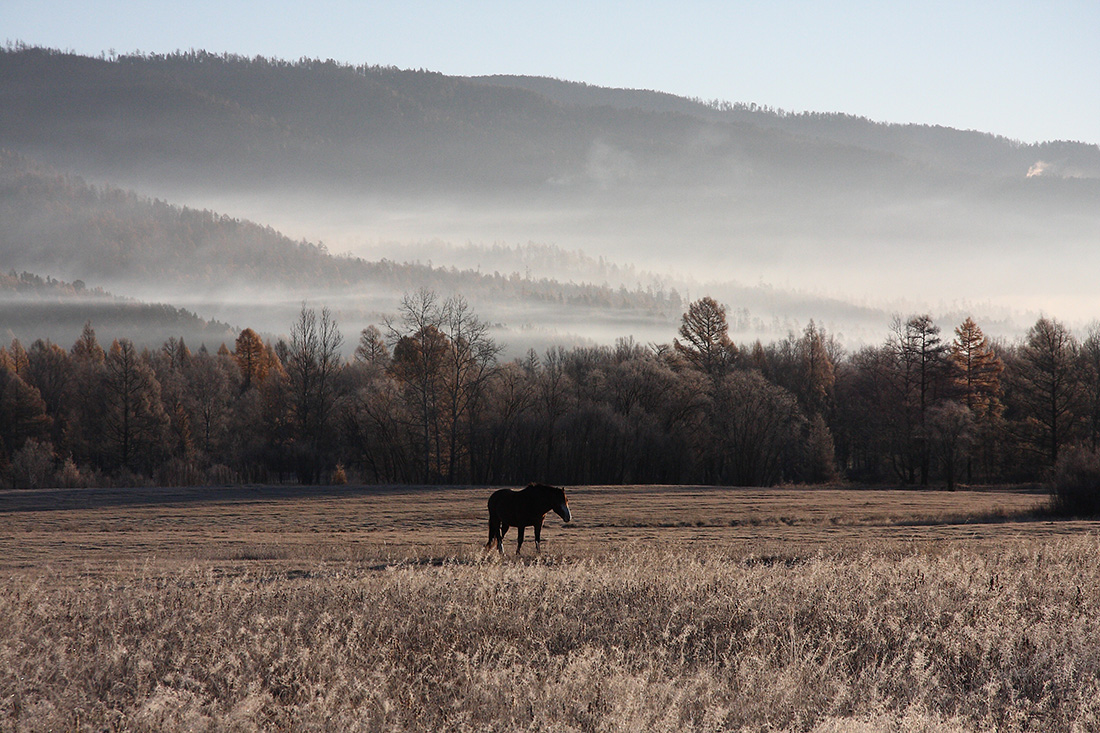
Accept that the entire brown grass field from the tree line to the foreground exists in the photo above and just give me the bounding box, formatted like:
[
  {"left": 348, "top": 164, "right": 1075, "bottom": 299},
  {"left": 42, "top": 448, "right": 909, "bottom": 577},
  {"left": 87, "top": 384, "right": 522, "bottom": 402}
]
[{"left": 0, "top": 486, "right": 1100, "bottom": 731}]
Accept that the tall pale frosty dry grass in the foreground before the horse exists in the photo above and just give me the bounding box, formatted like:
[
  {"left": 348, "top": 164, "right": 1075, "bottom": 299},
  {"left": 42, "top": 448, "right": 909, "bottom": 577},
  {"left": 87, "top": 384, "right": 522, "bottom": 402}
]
[{"left": 0, "top": 536, "right": 1100, "bottom": 731}]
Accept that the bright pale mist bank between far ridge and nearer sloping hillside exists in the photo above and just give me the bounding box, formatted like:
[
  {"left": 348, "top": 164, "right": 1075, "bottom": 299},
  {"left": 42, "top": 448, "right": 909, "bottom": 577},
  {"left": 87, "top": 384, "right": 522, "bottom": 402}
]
[{"left": 146, "top": 179, "right": 1082, "bottom": 342}]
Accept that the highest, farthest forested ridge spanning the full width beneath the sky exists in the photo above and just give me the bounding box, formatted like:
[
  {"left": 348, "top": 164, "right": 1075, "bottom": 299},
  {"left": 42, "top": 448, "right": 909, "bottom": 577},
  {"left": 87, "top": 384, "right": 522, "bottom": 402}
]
[{"left": 0, "top": 48, "right": 1100, "bottom": 195}]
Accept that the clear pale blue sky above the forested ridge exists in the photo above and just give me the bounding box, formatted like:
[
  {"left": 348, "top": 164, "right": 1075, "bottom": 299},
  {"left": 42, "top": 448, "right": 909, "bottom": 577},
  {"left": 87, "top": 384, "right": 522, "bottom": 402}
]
[{"left": 0, "top": 0, "right": 1100, "bottom": 143}]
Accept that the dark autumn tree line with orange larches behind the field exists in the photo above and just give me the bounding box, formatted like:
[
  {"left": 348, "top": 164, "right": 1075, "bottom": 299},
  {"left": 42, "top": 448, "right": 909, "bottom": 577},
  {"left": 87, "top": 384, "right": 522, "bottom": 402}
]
[{"left": 0, "top": 289, "right": 1100, "bottom": 489}]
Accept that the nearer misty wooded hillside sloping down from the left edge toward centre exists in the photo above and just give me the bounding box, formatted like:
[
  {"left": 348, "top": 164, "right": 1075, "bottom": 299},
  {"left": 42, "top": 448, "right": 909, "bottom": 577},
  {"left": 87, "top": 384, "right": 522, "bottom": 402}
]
[{"left": 0, "top": 151, "right": 682, "bottom": 311}]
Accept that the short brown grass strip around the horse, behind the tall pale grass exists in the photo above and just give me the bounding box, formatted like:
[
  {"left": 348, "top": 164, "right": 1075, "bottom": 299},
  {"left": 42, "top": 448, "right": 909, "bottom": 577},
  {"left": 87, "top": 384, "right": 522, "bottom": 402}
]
[{"left": 0, "top": 486, "right": 1051, "bottom": 572}]
